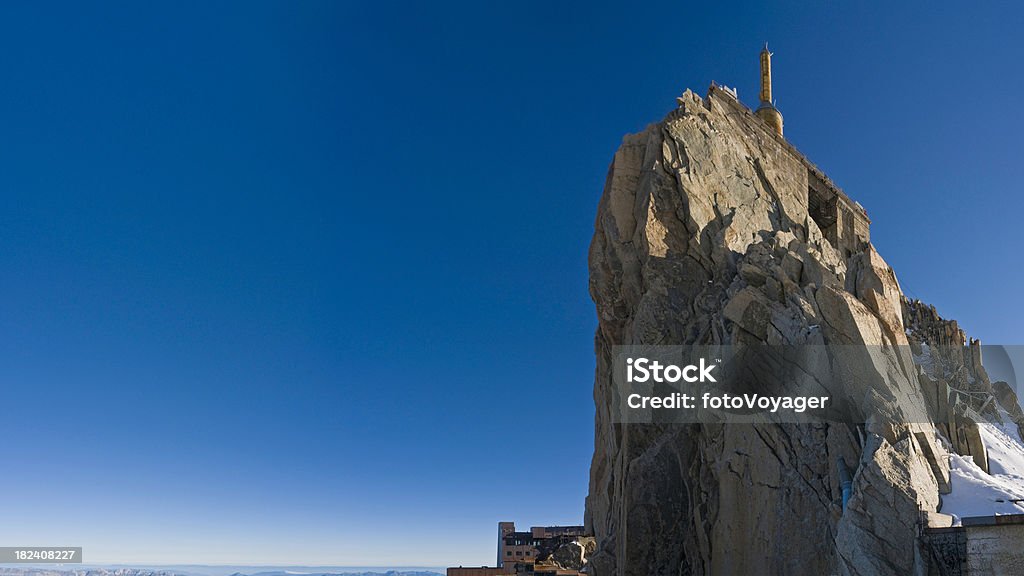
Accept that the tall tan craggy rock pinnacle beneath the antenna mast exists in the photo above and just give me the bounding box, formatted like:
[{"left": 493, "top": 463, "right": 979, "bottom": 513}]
[{"left": 586, "top": 87, "right": 999, "bottom": 576}]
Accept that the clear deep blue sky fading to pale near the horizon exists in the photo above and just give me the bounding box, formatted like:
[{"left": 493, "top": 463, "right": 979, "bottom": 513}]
[{"left": 0, "top": 2, "right": 1024, "bottom": 565}]
